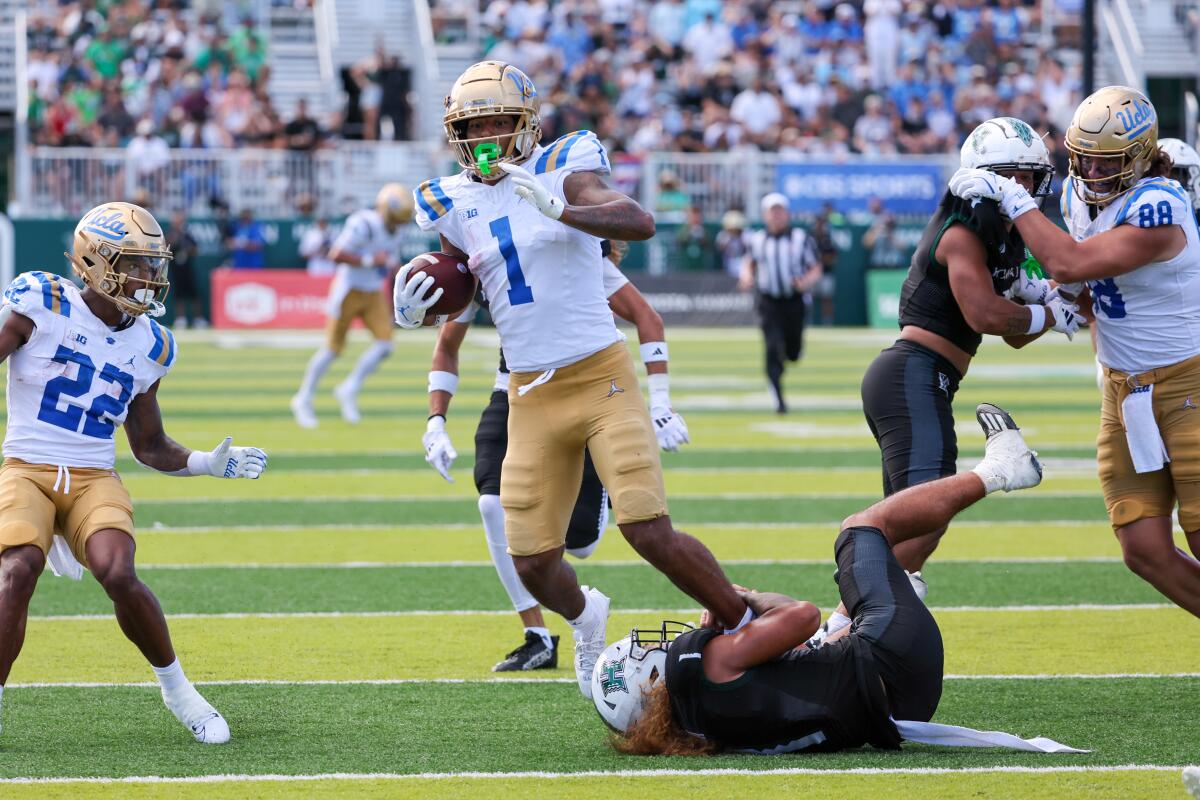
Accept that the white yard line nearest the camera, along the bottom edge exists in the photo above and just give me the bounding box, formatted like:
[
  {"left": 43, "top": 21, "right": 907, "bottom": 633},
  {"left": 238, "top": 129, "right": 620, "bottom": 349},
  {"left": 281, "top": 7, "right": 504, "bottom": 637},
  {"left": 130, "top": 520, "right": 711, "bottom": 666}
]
[{"left": 0, "top": 764, "right": 1186, "bottom": 784}]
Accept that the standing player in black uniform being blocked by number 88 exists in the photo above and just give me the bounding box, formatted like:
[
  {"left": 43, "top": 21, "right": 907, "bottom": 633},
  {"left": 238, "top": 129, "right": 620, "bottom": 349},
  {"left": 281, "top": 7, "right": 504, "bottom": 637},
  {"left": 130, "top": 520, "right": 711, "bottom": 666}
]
[{"left": 814, "top": 116, "right": 1081, "bottom": 644}]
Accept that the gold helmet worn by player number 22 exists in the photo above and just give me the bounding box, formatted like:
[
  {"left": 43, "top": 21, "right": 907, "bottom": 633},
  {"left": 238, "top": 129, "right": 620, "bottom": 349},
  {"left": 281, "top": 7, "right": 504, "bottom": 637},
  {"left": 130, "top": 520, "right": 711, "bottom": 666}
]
[{"left": 66, "top": 203, "right": 172, "bottom": 317}]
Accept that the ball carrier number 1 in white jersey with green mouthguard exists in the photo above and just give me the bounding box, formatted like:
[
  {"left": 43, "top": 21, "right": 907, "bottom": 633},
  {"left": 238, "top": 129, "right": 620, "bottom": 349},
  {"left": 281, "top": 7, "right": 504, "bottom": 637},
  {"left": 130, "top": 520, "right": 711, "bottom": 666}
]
[{"left": 395, "top": 61, "right": 751, "bottom": 697}]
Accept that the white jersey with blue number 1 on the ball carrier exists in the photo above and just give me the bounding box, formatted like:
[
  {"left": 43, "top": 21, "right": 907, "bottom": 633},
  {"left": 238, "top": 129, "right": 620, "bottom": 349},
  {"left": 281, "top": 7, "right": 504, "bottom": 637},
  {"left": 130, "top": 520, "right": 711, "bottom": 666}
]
[{"left": 414, "top": 131, "right": 624, "bottom": 372}]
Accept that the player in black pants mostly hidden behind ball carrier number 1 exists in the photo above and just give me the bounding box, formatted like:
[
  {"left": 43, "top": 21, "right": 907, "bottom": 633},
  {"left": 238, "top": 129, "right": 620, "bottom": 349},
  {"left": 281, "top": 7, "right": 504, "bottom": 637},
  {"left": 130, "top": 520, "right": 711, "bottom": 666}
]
[{"left": 421, "top": 241, "right": 688, "bottom": 672}]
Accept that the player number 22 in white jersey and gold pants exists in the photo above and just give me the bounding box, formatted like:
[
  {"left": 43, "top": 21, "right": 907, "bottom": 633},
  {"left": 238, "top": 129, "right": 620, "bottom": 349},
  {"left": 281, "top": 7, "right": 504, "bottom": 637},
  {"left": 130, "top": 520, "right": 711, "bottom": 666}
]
[{"left": 0, "top": 203, "right": 266, "bottom": 744}]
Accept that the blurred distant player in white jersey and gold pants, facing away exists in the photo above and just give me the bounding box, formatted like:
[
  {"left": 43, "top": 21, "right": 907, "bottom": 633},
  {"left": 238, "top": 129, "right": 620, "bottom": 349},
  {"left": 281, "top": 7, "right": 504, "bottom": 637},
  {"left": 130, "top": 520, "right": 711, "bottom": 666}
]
[{"left": 292, "top": 184, "right": 413, "bottom": 428}]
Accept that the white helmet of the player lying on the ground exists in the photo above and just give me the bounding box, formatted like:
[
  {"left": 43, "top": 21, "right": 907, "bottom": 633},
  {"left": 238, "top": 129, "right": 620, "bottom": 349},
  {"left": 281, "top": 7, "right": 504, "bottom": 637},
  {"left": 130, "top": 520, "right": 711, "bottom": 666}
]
[{"left": 592, "top": 631, "right": 667, "bottom": 733}]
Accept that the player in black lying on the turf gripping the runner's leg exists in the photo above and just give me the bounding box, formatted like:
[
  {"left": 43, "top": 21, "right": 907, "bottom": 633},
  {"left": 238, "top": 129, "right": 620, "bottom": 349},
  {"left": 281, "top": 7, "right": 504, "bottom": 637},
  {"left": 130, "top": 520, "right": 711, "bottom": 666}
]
[{"left": 592, "top": 404, "right": 1057, "bottom": 754}]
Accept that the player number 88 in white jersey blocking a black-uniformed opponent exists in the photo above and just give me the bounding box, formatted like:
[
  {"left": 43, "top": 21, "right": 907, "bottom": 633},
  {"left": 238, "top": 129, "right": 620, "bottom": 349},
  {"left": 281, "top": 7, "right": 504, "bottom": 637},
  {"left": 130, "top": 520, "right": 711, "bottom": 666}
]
[{"left": 950, "top": 86, "right": 1200, "bottom": 616}]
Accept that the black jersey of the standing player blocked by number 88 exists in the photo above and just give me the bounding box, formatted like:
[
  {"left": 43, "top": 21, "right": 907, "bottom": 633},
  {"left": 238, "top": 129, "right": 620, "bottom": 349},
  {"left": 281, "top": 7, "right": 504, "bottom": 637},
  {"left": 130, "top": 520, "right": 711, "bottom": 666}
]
[{"left": 900, "top": 192, "right": 1025, "bottom": 355}]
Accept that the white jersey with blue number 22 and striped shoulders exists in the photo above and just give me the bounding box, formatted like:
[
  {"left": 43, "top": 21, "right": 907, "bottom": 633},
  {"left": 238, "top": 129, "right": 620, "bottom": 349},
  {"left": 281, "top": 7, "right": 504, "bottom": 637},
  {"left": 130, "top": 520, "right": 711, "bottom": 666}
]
[{"left": 4, "top": 272, "right": 176, "bottom": 469}]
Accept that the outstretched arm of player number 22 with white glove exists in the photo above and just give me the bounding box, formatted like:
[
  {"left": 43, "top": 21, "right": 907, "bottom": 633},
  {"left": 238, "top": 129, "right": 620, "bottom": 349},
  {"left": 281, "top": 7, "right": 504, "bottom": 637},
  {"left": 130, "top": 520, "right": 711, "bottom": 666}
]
[{"left": 125, "top": 381, "right": 266, "bottom": 479}]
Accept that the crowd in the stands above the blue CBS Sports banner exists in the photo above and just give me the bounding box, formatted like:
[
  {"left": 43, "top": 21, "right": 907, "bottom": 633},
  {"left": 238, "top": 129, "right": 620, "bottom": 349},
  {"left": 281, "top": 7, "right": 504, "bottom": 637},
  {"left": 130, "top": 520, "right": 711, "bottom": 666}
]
[{"left": 468, "top": 0, "right": 1080, "bottom": 158}]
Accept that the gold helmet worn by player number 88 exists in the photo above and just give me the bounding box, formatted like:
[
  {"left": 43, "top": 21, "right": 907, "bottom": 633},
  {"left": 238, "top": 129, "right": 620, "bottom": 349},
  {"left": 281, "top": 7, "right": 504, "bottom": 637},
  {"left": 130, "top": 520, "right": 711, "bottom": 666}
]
[{"left": 1066, "top": 86, "right": 1158, "bottom": 205}]
